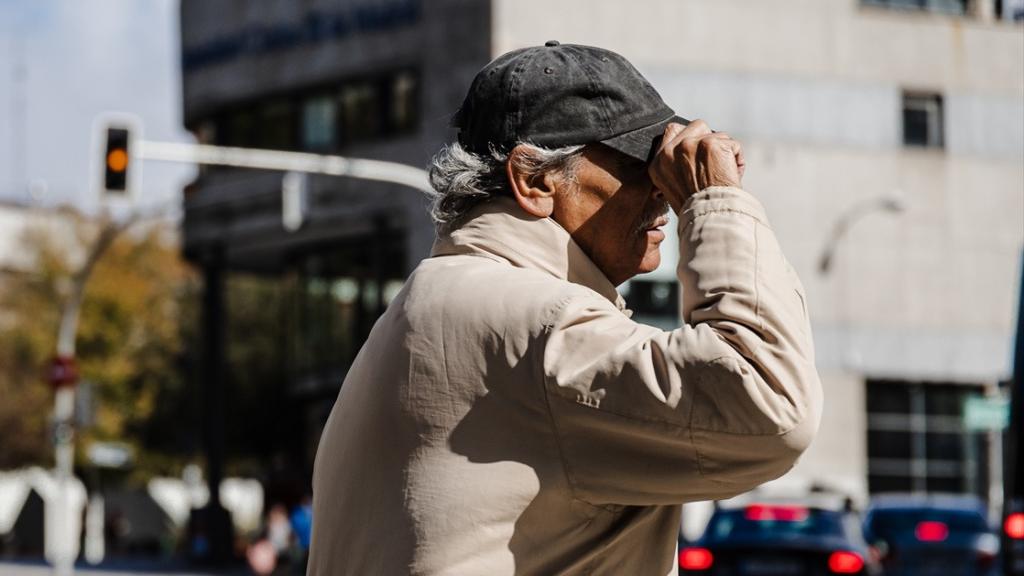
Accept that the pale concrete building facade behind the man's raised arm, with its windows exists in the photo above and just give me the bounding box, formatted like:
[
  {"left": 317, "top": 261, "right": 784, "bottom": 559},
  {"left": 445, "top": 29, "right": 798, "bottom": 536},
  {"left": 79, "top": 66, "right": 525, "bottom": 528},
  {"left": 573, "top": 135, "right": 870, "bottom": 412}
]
[{"left": 493, "top": 0, "right": 1024, "bottom": 500}]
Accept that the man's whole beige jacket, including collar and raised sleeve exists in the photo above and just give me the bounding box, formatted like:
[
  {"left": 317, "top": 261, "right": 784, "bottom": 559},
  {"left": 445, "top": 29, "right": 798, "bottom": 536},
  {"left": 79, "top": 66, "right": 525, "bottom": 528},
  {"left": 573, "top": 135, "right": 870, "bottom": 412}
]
[{"left": 308, "top": 188, "right": 821, "bottom": 576}]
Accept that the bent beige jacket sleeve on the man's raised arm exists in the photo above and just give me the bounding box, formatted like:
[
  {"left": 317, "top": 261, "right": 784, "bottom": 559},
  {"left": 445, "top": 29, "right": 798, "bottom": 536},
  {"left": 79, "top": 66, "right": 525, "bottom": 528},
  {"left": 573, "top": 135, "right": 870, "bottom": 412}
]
[{"left": 543, "top": 188, "right": 822, "bottom": 505}]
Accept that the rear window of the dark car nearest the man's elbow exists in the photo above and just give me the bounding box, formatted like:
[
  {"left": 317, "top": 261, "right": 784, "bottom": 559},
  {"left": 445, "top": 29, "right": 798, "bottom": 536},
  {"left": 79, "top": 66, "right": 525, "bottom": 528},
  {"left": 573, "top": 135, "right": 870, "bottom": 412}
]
[{"left": 705, "top": 505, "right": 843, "bottom": 540}]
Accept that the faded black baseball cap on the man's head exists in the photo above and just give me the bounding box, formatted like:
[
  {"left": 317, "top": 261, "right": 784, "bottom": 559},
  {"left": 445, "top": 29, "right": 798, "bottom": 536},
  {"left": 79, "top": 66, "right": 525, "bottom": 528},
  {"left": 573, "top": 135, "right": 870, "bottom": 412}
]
[{"left": 453, "top": 40, "right": 689, "bottom": 162}]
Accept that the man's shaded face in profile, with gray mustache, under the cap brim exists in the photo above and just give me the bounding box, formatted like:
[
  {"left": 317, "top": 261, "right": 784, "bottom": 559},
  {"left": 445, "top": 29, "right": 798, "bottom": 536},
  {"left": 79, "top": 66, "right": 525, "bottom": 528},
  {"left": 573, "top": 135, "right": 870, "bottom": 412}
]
[{"left": 552, "top": 145, "right": 669, "bottom": 286}]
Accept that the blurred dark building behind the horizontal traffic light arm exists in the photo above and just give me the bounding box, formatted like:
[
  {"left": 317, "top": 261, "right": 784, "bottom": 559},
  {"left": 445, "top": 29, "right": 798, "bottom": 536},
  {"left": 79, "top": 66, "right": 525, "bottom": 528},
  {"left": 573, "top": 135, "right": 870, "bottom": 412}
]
[{"left": 180, "top": 0, "right": 490, "bottom": 545}]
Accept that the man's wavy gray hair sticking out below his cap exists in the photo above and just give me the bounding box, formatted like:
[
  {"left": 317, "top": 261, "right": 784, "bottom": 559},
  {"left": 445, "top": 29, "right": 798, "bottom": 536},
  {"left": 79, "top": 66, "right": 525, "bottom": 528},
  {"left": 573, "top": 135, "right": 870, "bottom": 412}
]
[{"left": 429, "top": 142, "right": 584, "bottom": 232}]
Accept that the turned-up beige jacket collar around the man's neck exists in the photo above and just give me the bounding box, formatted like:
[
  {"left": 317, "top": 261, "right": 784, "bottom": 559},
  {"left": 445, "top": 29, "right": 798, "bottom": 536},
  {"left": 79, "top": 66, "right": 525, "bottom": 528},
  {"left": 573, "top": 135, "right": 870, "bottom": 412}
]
[{"left": 430, "top": 198, "right": 626, "bottom": 312}]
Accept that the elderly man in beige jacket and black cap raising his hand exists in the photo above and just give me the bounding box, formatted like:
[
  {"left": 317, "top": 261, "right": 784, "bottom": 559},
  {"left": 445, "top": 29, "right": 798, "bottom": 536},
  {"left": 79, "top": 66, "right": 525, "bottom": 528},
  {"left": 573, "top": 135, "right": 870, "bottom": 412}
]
[{"left": 308, "top": 41, "right": 821, "bottom": 576}]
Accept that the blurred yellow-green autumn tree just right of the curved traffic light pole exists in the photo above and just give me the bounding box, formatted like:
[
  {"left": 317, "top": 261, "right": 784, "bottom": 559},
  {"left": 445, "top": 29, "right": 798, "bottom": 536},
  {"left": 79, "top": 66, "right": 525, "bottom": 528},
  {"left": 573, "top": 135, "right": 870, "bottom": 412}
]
[{"left": 78, "top": 220, "right": 200, "bottom": 477}]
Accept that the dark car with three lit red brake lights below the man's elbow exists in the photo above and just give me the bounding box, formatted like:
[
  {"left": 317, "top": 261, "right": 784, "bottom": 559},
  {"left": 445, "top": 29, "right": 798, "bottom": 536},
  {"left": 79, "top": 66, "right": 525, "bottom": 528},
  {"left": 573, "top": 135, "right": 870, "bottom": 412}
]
[{"left": 679, "top": 500, "right": 878, "bottom": 576}]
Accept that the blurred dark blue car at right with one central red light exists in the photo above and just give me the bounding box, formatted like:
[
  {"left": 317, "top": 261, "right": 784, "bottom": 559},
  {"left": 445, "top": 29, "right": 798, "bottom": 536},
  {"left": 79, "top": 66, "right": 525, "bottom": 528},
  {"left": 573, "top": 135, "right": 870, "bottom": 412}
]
[{"left": 864, "top": 495, "right": 999, "bottom": 576}]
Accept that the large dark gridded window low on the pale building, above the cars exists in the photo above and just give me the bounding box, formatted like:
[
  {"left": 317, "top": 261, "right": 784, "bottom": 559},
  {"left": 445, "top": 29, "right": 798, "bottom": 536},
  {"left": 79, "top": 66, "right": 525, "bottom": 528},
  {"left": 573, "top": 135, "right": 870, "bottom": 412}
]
[{"left": 867, "top": 380, "right": 988, "bottom": 495}]
